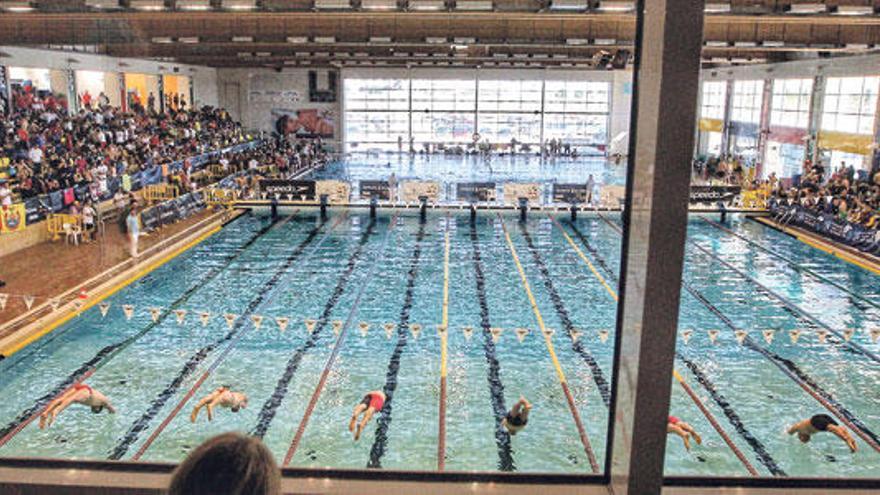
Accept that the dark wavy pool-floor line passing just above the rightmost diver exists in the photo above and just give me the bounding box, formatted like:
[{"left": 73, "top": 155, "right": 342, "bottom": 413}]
[{"left": 682, "top": 281, "right": 878, "bottom": 458}]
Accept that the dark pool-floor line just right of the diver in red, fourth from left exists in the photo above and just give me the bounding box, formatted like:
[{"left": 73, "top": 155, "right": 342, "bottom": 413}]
[{"left": 367, "top": 223, "right": 425, "bottom": 468}]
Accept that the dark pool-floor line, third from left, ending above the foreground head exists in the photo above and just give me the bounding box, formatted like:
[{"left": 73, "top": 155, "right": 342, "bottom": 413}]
[{"left": 250, "top": 219, "right": 376, "bottom": 438}]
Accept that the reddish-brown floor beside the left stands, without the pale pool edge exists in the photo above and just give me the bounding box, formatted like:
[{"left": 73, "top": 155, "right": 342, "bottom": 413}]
[{"left": 0, "top": 211, "right": 209, "bottom": 330}]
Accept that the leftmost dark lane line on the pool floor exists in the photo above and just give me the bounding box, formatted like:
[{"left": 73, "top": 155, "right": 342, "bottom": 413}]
[{"left": 0, "top": 212, "right": 296, "bottom": 447}]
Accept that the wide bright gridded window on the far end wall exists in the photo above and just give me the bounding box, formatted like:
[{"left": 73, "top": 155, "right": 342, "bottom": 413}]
[{"left": 344, "top": 75, "right": 611, "bottom": 152}]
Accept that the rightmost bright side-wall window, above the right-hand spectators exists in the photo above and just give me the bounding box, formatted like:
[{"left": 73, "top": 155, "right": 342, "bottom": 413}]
[{"left": 822, "top": 77, "right": 880, "bottom": 134}]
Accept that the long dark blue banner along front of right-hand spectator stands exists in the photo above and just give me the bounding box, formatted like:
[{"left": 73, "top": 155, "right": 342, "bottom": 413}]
[{"left": 770, "top": 201, "right": 880, "bottom": 252}]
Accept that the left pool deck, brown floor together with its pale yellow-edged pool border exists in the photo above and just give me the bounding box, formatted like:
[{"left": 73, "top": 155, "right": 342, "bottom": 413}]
[{"left": 0, "top": 210, "right": 241, "bottom": 357}]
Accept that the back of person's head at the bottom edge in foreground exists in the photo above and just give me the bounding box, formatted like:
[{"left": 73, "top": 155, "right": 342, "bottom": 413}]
[{"left": 168, "top": 433, "right": 281, "bottom": 495}]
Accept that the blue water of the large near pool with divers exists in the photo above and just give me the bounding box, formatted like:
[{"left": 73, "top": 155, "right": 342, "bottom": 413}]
[{"left": 0, "top": 209, "right": 880, "bottom": 477}]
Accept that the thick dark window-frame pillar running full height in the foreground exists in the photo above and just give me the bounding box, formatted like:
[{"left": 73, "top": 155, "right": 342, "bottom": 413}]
[{"left": 609, "top": 0, "right": 703, "bottom": 495}]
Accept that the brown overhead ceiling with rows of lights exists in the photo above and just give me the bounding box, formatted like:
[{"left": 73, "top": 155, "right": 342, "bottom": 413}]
[{"left": 0, "top": 0, "right": 880, "bottom": 67}]
